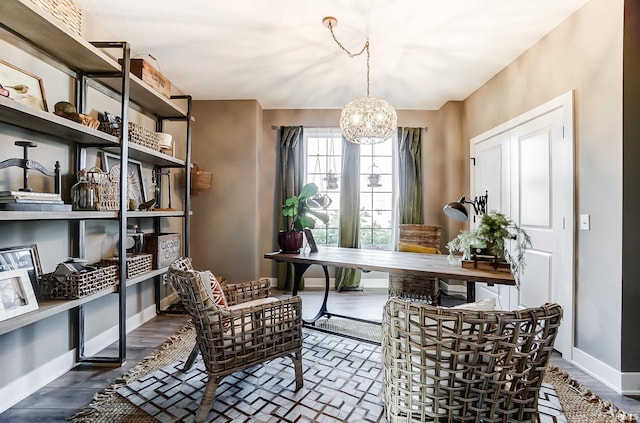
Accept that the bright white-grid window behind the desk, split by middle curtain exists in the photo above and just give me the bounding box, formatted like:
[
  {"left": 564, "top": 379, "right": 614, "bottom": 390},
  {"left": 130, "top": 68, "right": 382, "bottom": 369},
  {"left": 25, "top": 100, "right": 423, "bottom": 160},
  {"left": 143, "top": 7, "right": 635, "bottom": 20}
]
[{"left": 304, "top": 128, "right": 396, "bottom": 249}]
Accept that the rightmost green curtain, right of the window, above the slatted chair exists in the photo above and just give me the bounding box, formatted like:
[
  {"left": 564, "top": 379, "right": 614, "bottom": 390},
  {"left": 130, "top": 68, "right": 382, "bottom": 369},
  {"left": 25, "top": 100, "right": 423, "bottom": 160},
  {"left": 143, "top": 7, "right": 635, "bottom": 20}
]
[{"left": 398, "top": 128, "right": 424, "bottom": 224}]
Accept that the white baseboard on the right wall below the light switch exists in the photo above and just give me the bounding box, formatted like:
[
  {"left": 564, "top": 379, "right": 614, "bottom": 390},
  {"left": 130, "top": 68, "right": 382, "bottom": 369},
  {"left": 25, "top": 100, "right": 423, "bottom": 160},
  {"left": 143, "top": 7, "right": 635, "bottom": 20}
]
[{"left": 572, "top": 348, "right": 640, "bottom": 395}]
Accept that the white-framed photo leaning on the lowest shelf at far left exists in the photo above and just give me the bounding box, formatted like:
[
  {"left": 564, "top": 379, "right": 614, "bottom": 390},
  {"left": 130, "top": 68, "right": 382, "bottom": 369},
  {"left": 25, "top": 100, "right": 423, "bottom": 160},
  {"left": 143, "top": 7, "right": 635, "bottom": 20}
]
[{"left": 0, "top": 269, "right": 38, "bottom": 321}]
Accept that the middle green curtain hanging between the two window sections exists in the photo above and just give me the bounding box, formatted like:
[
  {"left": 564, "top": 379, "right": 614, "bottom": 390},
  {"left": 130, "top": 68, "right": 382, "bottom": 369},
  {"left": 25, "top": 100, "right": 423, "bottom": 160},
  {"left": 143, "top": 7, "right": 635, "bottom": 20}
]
[{"left": 335, "top": 137, "right": 362, "bottom": 291}]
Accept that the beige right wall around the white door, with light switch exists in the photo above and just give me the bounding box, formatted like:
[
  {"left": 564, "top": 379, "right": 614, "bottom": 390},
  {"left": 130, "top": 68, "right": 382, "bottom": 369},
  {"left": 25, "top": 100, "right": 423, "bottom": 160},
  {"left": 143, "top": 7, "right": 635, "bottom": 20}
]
[{"left": 464, "top": 0, "right": 623, "bottom": 370}]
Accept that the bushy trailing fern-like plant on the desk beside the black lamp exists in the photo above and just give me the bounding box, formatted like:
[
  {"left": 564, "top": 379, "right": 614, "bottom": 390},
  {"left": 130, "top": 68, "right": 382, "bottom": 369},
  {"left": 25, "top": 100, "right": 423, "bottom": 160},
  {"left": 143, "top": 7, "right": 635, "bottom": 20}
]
[{"left": 447, "top": 211, "right": 531, "bottom": 277}]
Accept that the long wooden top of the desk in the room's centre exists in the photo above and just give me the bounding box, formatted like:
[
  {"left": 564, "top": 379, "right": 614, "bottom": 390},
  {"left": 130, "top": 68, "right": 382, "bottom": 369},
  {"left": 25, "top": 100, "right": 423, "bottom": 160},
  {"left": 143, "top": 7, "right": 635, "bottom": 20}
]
[{"left": 264, "top": 246, "right": 516, "bottom": 285}]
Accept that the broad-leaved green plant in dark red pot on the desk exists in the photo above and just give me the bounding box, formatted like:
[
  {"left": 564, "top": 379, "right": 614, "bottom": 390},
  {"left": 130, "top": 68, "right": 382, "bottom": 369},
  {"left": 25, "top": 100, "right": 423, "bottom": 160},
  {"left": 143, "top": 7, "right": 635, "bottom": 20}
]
[{"left": 278, "top": 182, "right": 329, "bottom": 253}]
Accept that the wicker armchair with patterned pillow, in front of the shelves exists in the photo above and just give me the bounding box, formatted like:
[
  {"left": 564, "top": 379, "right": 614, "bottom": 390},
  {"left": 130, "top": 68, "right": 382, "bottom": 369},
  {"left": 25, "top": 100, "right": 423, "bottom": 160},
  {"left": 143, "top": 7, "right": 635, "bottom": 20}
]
[{"left": 167, "top": 258, "right": 303, "bottom": 422}]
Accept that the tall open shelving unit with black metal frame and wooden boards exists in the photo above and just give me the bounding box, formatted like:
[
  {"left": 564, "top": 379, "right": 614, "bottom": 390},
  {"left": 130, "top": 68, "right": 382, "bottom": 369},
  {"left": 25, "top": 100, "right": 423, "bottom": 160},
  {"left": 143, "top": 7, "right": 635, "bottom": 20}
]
[{"left": 0, "top": 0, "right": 193, "bottom": 364}]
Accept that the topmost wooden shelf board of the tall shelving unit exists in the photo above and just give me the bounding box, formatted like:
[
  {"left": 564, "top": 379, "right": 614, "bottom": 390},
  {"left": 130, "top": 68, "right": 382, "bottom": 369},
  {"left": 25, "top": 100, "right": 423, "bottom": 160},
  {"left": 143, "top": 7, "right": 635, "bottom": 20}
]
[{"left": 0, "top": 0, "right": 187, "bottom": 117}]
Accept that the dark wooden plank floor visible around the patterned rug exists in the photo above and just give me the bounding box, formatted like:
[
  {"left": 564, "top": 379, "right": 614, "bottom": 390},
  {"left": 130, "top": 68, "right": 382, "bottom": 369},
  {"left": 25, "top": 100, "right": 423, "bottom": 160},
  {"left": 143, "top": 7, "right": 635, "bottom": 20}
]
[{"left": 0, "top": 289, "right": 640, "bottom": 423}]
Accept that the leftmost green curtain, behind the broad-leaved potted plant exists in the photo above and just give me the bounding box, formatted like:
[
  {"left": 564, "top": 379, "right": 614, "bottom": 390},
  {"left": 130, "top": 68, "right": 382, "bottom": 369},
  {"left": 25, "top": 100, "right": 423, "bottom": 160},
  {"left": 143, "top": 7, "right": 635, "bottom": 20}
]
[{"left": 276, "top": 126, "right": 304, "bottom": 290}]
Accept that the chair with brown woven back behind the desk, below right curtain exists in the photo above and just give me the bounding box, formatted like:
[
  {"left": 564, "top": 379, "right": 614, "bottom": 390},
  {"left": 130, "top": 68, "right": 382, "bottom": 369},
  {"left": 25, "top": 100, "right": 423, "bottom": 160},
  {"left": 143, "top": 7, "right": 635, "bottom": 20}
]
[{"left": 389, "top": 223, "right": 441, "bottom": 304}]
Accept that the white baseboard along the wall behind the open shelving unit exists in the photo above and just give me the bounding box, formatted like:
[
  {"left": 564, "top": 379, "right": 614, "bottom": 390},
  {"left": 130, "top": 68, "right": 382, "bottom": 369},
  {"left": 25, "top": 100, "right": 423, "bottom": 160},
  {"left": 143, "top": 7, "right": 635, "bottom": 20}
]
[{"left": 0, "top": 304, "right": 156, "bottom": 413}]
